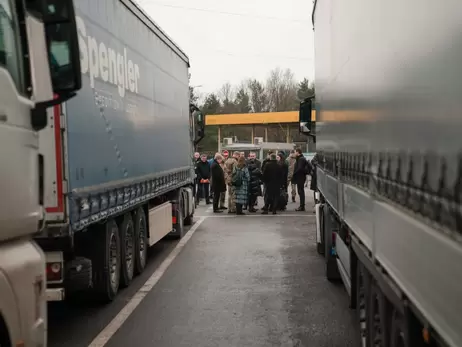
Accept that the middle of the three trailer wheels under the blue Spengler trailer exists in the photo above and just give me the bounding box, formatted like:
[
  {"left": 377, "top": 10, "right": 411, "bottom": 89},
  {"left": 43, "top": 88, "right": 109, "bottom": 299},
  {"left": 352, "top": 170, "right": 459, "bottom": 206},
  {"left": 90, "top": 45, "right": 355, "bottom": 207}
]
[{"left": 119, "top": 213, "right": 135, "bottom": 287}]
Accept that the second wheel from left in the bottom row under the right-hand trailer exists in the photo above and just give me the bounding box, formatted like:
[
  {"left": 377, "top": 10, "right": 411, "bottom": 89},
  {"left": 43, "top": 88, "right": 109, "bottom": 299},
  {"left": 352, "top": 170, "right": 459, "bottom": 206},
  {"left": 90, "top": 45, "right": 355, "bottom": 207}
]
[{"left": 368, "top": 281, "right": 389, "bottom": 347}]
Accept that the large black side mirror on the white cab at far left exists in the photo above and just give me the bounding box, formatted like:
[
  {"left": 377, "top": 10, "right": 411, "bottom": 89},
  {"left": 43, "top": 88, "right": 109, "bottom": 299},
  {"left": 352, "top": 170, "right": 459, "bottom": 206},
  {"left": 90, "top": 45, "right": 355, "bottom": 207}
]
[{"left": 41, "top": 0, "right": 82, "bottom": 95}]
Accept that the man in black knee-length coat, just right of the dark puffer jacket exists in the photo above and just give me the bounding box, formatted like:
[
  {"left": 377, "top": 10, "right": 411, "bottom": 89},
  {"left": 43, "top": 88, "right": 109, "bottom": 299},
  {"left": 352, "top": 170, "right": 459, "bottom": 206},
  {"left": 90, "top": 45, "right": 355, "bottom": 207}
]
[{"left": 262, "top": 154, "right": 284, "bottom": 214}]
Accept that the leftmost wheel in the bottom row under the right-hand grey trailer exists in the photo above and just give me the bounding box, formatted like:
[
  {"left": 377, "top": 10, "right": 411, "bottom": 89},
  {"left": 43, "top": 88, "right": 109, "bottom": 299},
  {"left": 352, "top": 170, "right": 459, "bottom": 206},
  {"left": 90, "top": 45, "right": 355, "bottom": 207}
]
[{"left": 356, "top": 261, "right": 371, "bottom": 347}]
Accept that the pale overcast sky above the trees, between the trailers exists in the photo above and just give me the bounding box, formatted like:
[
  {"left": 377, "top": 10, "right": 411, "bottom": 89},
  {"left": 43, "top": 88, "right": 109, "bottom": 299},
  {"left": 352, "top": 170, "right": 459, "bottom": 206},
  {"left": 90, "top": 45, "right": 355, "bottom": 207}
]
[{"left": 137, "top": 0, "right": 314, "bottom": 93}]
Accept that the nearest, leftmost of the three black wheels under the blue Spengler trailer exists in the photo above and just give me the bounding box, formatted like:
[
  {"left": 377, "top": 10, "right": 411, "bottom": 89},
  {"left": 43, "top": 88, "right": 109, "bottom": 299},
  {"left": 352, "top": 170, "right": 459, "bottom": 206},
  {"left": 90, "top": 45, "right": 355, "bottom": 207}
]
[{"left": 90, "top": 219, "right": 121, "bottom": 302}]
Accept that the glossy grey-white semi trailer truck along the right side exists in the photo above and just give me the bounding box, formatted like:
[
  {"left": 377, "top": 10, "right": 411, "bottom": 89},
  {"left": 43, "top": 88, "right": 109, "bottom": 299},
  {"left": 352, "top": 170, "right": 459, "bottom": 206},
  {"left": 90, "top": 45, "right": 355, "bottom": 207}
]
[{"left": 300, "top": 0, "right": 462, "bottom": 347}]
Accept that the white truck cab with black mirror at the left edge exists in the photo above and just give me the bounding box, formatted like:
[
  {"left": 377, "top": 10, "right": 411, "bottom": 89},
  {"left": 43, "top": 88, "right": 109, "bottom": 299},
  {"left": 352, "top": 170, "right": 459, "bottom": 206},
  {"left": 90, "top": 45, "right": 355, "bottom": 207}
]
[{"left": 0, "top": 0, "right": 80, "bottom": 346}]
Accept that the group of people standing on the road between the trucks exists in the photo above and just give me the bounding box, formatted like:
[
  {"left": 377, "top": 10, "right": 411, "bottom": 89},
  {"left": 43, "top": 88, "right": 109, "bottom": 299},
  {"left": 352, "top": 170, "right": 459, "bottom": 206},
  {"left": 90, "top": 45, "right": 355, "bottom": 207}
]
[{"left": 194, "top": 149, "right": 312, "bottom": 215}]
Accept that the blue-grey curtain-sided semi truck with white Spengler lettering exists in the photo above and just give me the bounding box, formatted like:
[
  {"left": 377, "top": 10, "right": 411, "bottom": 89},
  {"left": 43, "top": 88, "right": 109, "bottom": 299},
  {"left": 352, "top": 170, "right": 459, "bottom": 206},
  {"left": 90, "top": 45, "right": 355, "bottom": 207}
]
[{"left": 36, "top": 0, "right": 204, "bottom": 301}]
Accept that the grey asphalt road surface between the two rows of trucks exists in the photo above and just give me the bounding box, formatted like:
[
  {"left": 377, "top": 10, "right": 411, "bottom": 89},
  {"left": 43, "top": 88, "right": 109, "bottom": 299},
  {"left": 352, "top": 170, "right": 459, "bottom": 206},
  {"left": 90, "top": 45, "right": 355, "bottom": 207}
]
[{"left": 49, "top": 196, "right": 357, "bottom": 347}]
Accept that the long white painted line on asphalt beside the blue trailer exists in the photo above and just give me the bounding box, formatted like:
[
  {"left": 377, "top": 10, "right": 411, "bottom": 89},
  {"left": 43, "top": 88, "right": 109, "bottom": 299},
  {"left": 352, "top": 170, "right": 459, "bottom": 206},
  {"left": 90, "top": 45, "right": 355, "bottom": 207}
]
[{"left": 88, "top": 216, "right": 207, "bottom": 347}]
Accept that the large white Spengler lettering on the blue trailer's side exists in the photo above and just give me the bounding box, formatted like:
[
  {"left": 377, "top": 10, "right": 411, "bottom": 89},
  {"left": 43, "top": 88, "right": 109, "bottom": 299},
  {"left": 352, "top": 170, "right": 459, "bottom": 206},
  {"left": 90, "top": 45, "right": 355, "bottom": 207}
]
[{"left": 76, "top": 16, "right": 140, "bottom": 97}]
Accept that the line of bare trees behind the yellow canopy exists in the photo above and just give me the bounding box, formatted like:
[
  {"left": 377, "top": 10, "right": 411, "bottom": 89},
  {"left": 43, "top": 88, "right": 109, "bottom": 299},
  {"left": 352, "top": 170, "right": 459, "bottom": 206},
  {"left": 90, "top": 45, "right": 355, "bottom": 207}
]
[{"left": 189, "top": 68, "right": 314, "bottom": 115}]
